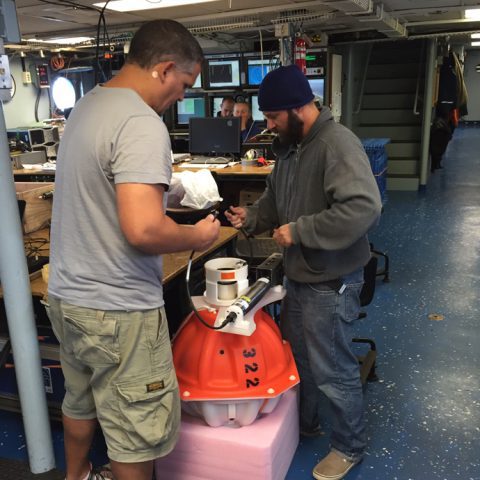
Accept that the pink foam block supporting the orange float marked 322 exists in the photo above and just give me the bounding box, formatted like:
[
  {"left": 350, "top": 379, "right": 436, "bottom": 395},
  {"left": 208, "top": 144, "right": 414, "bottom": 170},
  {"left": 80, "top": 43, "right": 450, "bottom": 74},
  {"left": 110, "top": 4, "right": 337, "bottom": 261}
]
[{"left": 155, "top": 390, "right": 299, "bottom": 480}]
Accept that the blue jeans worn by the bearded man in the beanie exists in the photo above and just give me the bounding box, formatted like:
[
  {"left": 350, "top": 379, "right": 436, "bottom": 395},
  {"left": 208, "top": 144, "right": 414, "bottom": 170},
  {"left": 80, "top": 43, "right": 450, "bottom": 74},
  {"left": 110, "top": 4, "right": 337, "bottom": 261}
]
[{"left": 281, "top": 269, "right": 366, "bottom": 460}]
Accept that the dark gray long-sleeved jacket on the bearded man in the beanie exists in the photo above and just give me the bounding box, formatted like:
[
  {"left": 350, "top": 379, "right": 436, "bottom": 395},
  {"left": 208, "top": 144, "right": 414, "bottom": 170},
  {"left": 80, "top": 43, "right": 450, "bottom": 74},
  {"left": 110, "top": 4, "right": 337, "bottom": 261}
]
[{"left": 245, "top": 107, "right": 382, "bottom": 283}]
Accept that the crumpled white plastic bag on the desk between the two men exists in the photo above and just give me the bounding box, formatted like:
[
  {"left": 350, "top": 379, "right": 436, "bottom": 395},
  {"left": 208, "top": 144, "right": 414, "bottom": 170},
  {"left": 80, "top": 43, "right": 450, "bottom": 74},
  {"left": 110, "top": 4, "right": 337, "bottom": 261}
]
[{"left": 180, "top": 170, "right": 222, "bottom": 210}]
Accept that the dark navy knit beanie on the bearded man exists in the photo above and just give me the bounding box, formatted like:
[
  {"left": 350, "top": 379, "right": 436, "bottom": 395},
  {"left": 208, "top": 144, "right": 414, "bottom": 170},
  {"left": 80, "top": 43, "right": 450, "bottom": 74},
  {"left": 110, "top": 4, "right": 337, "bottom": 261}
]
[{"left": 258, "top": 65, "right": 314, "bottom": 112}]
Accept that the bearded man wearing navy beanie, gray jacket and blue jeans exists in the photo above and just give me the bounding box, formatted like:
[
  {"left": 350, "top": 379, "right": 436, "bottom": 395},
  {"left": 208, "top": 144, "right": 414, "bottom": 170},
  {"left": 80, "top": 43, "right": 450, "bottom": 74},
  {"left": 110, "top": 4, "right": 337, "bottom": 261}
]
[{"left": 226, "top": 65, "right": 381, "bottom": 480}]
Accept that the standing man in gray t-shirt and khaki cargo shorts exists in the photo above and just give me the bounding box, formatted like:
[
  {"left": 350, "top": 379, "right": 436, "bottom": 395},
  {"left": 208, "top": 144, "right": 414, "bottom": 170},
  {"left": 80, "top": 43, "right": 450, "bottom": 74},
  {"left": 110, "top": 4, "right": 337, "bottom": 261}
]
[{"left": 48, "top": 20, "right": 219, "bottom": 480}]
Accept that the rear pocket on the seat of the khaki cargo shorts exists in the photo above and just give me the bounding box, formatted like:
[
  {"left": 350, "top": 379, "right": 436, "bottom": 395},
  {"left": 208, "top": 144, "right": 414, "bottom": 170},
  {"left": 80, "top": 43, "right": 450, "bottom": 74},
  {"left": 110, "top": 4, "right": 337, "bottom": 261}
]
[{"left": 62, "top": 304, "right": 120, "bottom": 367}]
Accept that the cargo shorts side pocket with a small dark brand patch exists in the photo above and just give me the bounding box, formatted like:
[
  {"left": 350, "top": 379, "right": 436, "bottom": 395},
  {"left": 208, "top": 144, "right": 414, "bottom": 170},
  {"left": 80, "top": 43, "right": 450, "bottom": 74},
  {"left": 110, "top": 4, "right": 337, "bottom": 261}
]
[{"left": 116, "top": 368, "right": 180, "bottom": 449}]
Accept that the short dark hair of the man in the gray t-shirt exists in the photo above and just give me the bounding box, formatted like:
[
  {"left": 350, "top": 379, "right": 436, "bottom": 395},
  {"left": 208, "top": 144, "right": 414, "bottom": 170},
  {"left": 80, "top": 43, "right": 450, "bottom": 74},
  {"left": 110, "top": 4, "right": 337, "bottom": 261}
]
[{"left": 127, "top": 19, "right": 203, "bottom": 70}]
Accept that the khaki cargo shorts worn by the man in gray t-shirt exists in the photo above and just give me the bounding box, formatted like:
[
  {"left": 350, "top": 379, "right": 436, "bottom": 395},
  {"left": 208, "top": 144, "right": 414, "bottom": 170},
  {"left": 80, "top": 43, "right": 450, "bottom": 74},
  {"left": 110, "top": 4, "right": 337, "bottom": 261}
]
[{"left": 46, "top": 297, "right": 180, "bottom": 463}]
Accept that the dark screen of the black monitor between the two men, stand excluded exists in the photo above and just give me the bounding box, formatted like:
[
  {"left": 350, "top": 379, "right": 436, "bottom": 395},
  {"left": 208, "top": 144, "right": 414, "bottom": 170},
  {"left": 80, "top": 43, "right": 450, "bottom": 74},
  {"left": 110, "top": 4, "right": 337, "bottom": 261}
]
[{"left": 189, "top": 117, "right": 240, "bottom": 156}]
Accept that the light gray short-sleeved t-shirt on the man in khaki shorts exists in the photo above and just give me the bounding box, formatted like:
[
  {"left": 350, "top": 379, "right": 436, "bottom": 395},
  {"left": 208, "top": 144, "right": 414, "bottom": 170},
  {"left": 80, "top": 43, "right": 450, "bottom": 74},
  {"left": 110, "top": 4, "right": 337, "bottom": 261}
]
[{"left": 48, "top": 86, "right": 172, "bottom": 310}]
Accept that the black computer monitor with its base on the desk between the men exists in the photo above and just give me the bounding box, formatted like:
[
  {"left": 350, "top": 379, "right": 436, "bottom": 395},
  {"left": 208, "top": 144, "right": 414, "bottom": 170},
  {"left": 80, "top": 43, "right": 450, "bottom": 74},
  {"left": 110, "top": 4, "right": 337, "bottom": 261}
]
[{"left": 189, "top": 117, "right": 241, "bottom": 165}]
